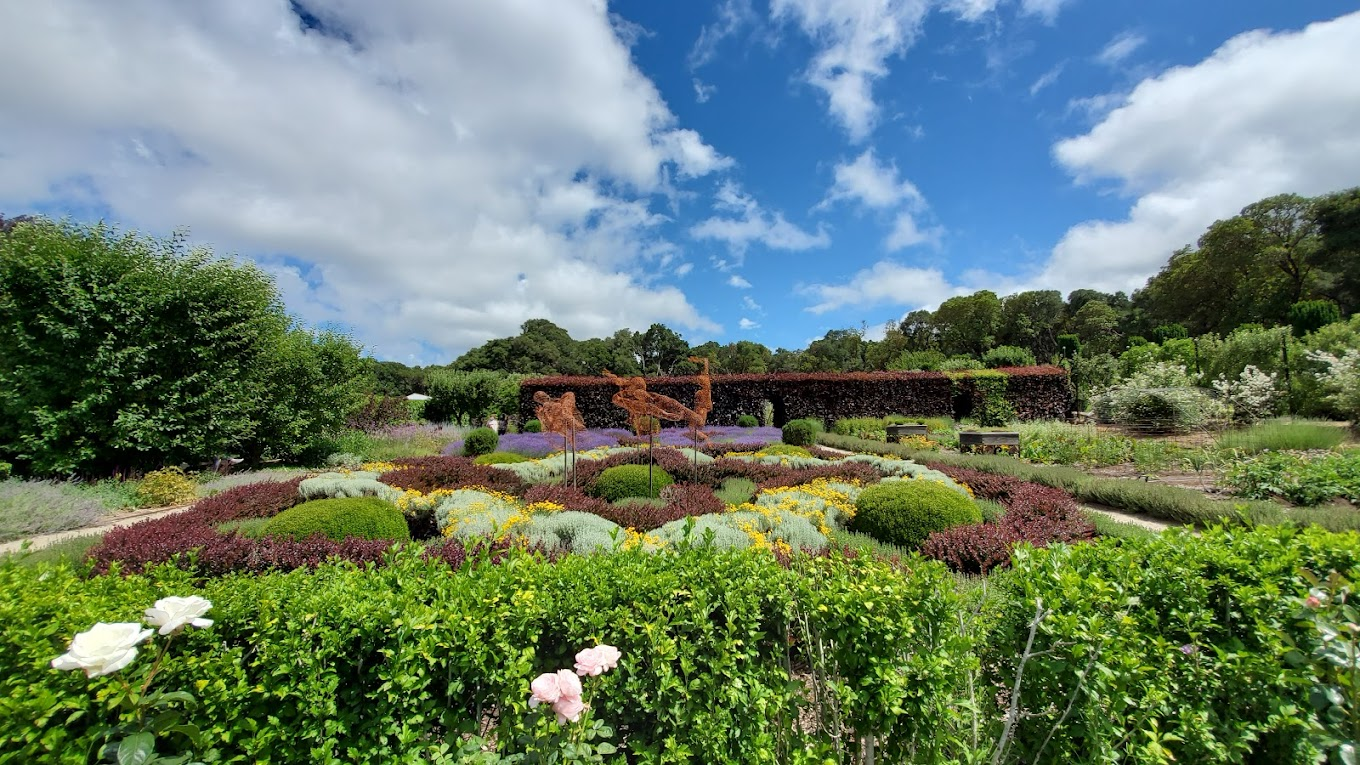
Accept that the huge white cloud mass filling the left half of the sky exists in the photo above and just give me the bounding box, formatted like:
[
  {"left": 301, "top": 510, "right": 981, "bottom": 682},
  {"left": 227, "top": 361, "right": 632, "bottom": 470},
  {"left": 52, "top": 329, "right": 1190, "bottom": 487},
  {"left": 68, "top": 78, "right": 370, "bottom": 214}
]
[{"left": 0, "top": 0, "right": 734, "bottom": 362}]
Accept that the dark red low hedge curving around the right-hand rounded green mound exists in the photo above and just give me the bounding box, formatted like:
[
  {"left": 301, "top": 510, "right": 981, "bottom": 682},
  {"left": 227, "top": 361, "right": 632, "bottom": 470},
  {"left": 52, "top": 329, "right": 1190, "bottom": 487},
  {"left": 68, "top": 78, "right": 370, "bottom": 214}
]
[{"left": 921, "top": 466, "right": 1096, "bottom": 573}]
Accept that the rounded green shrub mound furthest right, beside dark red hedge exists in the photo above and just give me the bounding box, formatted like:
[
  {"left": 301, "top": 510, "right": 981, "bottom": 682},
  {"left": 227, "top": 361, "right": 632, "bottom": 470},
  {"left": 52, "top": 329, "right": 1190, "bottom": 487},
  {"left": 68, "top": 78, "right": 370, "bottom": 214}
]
[{"left": 850, "top": 481, "right": 982, "bottom": 549}]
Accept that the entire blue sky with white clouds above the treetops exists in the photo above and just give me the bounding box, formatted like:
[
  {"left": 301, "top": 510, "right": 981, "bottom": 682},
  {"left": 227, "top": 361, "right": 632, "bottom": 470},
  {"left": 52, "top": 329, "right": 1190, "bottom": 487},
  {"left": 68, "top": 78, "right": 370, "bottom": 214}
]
[{"left": 0, "top": 0, "right": 1360, "bottom": 363}]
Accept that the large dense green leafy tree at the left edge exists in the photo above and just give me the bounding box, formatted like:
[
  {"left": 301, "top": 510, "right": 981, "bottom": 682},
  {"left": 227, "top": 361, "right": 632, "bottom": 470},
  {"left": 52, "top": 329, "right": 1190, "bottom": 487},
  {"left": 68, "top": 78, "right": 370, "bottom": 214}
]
[{"left": 0, "top": 219, "right": 363, "bottom": 475}]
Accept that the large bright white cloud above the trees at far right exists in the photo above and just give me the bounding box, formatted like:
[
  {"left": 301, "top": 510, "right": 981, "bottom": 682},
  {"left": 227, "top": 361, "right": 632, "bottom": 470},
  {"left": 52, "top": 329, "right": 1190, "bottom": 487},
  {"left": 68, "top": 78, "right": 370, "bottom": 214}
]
[{"left": 1038, "top": 14, "right": 1360, "bottom": 290}]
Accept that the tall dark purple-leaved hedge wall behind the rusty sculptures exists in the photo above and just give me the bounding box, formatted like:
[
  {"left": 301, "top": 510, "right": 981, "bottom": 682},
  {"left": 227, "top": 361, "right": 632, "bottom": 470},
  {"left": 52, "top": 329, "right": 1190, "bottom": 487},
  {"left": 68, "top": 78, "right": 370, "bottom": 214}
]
[{"left": 520, "top": 366, "right": 1072, "bottom": 427}]
